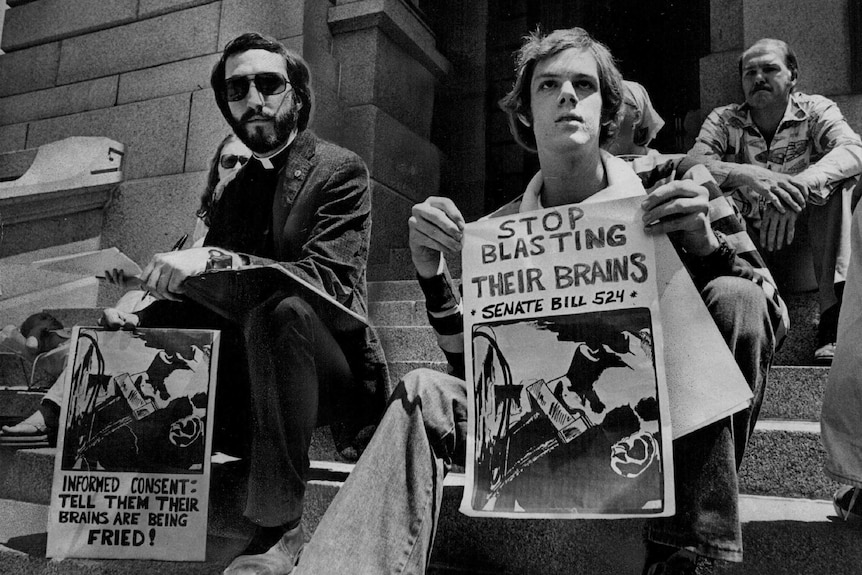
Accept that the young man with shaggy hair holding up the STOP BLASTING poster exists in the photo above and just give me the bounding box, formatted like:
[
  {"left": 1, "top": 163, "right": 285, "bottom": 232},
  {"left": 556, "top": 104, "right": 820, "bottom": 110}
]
[{"left": 288, "top": 28, "right": 786, "bottom": 575}]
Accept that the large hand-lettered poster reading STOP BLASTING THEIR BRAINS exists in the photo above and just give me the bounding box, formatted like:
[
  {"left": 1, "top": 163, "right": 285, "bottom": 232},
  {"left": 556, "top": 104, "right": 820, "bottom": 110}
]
[{"left": 461, "top": 198, "right": 674, "bottom": 518}]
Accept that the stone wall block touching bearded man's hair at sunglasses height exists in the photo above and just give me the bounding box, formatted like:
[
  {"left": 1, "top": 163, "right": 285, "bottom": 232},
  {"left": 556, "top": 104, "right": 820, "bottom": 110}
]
[{"left": 117, "top": 54, "right": 219, "bottom": 104}]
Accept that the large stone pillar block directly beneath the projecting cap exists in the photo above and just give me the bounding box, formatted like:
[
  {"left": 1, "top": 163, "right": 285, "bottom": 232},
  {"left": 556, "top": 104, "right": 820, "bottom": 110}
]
[{"left": 335, "top": 28, "right": 436, "bottom": 138}]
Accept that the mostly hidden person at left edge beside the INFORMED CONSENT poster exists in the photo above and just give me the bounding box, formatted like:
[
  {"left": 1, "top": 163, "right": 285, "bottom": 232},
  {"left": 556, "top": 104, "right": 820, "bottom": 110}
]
[{"left": 0, "top": 312, "right": 69, "bottom": 448}]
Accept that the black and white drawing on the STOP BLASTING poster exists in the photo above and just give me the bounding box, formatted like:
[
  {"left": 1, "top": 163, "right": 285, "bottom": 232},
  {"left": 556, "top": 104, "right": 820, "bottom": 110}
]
[{"left": 472, "top": 308, "right": 665, "bottom": 515}]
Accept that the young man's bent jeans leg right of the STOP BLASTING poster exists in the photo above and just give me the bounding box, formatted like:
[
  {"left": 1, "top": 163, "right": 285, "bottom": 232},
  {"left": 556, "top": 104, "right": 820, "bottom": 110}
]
[{"left": 645, "top": 276, "right": 775, "bottom": 562}]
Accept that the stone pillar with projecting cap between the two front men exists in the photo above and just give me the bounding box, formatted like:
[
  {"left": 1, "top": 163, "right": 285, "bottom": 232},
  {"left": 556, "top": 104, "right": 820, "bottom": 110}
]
[{"left": 328, "top": 0, "right": 449, "bottom": 278}]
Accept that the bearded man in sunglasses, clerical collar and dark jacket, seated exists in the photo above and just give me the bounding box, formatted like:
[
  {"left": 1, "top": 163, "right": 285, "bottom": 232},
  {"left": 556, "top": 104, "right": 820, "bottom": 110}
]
[{"left": 98, "top": 33, "right": 388, "bottom": 575}]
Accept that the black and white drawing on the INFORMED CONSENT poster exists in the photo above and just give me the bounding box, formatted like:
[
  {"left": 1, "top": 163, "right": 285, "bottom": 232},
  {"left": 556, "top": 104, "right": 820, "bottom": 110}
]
[{"left": 61, "top": 328, "right": 213, "bottom": 473}]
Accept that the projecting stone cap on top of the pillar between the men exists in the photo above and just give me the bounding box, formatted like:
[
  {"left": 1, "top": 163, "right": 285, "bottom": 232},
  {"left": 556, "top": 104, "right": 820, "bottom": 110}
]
[{"left": 329, "top": 0, "right": 451, "bottom": 78}]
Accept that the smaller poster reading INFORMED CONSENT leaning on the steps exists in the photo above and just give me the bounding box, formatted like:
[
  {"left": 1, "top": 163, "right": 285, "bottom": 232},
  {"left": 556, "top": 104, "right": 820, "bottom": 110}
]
[{"left": 47, "top": 327, "right": 219, "bottom": 561}]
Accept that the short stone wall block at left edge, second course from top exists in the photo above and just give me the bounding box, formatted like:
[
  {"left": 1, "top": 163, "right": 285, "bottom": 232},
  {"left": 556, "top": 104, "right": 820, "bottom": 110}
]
[{"left": 0, "top": 42, "right": 60, "bottom": 96}]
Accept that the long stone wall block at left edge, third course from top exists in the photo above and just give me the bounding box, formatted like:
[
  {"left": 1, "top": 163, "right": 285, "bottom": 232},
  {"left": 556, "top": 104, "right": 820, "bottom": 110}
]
[{"left": 0, "top": 76, "right": 117, "bottom": 125}]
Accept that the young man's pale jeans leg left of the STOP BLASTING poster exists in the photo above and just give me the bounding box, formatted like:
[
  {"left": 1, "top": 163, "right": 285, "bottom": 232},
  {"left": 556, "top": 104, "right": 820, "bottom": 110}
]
[{"left": 294, "top": 369, "right": 467, "bottom": 575}]
